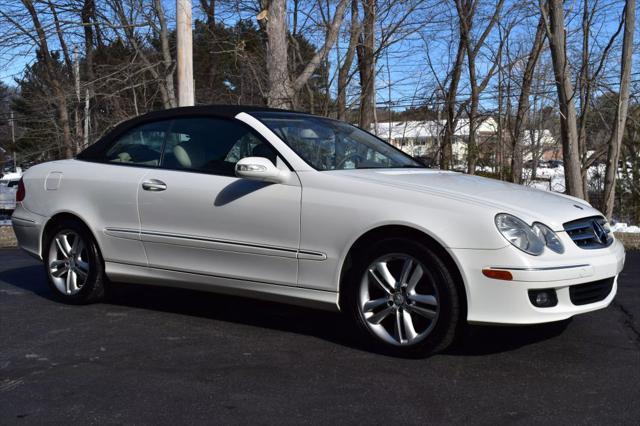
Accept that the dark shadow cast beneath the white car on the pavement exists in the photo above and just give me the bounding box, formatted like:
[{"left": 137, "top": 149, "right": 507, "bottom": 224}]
[{"left": 0, "top": 265, "right": 569, "bottom": 356}]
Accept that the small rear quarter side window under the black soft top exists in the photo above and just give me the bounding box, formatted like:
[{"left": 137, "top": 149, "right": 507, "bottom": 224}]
[{"left": 105, "top": 121, "right": 170, "bottom": 166}]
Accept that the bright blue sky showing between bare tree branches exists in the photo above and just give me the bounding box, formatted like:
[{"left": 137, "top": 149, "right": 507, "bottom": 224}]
[{"left": 0, "top": 0, "right": 640, "bottom": 110}]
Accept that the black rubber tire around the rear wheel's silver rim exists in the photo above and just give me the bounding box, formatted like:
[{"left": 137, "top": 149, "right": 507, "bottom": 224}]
[{"left": 43, "top": 219, "right": 107, "bottom": 305}]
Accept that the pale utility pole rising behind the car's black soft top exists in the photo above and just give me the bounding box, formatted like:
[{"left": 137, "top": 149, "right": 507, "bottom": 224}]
[{"left": 176, "top": 0, "right": 194, "bottom": 106}]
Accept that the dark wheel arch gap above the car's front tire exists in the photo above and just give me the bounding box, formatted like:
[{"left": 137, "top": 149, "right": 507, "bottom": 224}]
[{"left": 338, "top": 225, "right": 468, "bottom": 319}]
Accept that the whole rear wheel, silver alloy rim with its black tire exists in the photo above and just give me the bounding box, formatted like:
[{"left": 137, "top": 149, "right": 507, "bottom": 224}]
[{"left": 45, "top": 220, "right": 106, "bottom": 304}]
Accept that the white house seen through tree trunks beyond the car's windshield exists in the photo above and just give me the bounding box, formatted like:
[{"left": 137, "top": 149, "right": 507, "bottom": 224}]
[{"left": 374, "top": 117, "right": 498, "bottom": 163}]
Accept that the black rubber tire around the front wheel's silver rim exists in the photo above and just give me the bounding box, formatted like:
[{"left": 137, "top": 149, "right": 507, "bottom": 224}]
[{"left": 342, "top": 238, "right": 462, "bottom": 358}]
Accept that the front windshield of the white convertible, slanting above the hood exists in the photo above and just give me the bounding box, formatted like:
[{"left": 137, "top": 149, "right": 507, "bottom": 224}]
[{"left": 252, "top": 112, "right": 424, "bottom": 170}]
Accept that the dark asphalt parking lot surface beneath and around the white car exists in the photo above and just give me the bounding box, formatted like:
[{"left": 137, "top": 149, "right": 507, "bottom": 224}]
[{"left": 0, "top": 249, "right": 640, "bottom": 425}]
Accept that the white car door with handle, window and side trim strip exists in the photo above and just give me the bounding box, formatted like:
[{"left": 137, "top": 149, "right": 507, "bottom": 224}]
[{"left": 138, "top": 117, "right": 301, "bottom": 285}]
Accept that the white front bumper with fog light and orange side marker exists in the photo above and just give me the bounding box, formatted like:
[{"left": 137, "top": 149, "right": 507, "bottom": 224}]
[{"left": 452, "top": 235, "right": 625, "bottom": 324}]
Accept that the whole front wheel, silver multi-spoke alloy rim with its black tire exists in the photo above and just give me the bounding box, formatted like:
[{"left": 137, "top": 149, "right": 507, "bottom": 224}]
[{"left": 343, "top": 239, "right": 460, "bottom": 357}]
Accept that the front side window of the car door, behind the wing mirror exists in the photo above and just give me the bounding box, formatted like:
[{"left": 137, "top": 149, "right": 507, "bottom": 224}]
[{"left": 162, "top": 118, "right": 276, "bottom": 176}]
